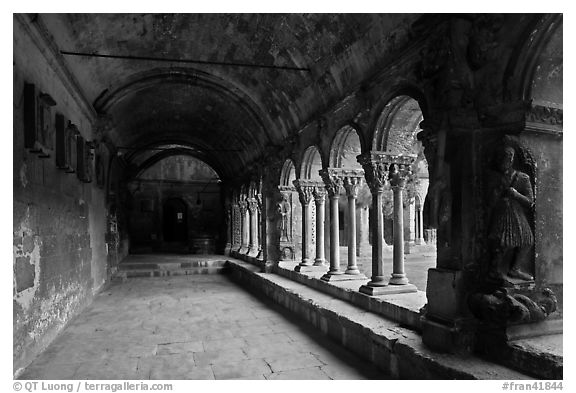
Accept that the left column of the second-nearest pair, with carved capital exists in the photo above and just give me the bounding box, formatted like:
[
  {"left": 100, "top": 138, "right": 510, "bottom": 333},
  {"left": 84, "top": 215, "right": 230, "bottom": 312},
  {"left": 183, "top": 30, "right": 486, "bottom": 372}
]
[{"left": 320, "top": 168, "right": 343, "bottom": 281}]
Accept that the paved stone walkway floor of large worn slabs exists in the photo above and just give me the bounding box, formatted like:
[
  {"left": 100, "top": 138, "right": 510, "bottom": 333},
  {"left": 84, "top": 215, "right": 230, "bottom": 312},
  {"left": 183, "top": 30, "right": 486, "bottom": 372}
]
[{"left": 20, "top": 274, "right": 387, "bottom": 380}]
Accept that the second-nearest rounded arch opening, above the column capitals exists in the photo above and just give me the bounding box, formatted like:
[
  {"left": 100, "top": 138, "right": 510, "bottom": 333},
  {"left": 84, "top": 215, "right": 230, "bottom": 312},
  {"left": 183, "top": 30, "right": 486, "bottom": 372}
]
[{"left": 329, "top": 125, "right": 362, "bottom": 168}]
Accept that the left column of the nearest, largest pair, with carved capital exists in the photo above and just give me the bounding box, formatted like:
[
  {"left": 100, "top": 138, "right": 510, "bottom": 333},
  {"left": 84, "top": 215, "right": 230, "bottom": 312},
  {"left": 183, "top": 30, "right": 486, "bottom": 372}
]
[{"left": 358, "top": 152, "right": 389, "bottom": 295}]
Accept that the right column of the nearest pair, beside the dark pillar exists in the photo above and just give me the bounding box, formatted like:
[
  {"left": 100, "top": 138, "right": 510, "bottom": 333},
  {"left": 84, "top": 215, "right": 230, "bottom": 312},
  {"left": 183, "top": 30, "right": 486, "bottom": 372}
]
[{"left": 389, "top": 163, "right": 416, "bottom": 290}]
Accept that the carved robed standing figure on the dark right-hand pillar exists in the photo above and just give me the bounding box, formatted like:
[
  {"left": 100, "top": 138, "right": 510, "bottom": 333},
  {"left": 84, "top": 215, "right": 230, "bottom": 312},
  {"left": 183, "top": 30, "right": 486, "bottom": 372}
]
[{"left": 488, "top": 146, "right": 534, "bottom": 282}]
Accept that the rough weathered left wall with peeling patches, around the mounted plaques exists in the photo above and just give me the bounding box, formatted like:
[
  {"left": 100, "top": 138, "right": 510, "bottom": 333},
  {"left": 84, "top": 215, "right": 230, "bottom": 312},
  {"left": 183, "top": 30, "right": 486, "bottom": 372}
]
[{"left": 13, "top": 21, "right": 107, "bottom": 373}]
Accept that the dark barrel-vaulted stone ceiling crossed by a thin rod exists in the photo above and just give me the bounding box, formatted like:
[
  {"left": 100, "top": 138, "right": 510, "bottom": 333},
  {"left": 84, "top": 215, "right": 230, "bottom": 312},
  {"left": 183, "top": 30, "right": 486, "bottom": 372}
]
[{"left": 38, "top": 14, "right": 419, "bottom": 176}]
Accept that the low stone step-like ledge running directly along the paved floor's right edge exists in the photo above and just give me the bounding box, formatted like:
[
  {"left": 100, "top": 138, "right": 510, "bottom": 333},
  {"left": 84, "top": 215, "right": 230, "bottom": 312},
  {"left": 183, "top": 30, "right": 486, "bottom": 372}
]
[{"left": 228, "top": 259, "right": 529, "bottom": 380}]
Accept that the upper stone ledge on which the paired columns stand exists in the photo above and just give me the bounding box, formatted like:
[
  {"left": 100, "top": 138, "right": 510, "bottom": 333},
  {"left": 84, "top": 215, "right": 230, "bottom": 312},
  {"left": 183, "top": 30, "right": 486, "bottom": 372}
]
[{"left": 273, "top": 264, "right": 426, "bottom": 331}]
